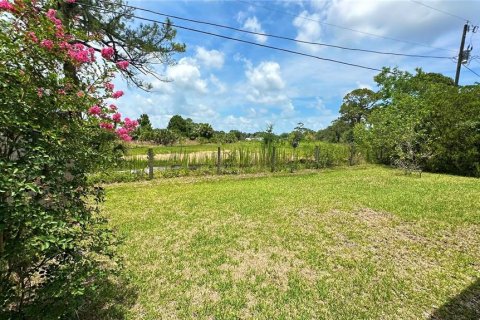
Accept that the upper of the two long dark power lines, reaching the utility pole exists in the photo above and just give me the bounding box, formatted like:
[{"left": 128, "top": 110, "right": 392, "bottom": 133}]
[{"left": 110, "top": 1, "right": 451, "bottom": 59}]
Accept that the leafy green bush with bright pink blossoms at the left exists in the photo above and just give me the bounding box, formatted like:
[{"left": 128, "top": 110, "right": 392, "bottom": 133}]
[{"left": 0, "top": 0, "right": 183, "bottom": 319}]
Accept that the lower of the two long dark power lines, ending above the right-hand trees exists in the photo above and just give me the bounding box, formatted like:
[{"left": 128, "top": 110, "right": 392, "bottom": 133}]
[{"left": 78, "top": 3, "right": 382, "bottom": 72}]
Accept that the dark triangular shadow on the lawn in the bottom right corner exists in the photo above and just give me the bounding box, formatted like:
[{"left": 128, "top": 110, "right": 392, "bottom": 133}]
[{"left": 430, "top": 279, "right": 480, "bottom": 320}]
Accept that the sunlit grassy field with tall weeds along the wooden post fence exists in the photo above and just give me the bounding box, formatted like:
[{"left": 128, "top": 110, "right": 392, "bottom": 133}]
[{"left": 96, "top": 141, "right": 352, "bottom": 182}]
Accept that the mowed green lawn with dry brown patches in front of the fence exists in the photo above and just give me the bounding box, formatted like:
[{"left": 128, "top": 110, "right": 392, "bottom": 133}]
[{"left": 104, "top": 166, "right": 480, "bottom": 319}]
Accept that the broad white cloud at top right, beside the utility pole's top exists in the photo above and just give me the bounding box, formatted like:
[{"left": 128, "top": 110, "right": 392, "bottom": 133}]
[{"left": 325, "top": 0, "right": 478, "bottom": 48}]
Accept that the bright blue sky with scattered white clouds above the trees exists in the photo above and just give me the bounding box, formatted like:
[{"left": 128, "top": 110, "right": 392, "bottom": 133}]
[{"left": 113, "top": 0, "right": 480, "bottom": 133}]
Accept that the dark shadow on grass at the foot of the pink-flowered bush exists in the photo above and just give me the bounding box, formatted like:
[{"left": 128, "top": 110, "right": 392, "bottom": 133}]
[{"left": 76, "top": 275, "right": 138, "bottom": 320}]
